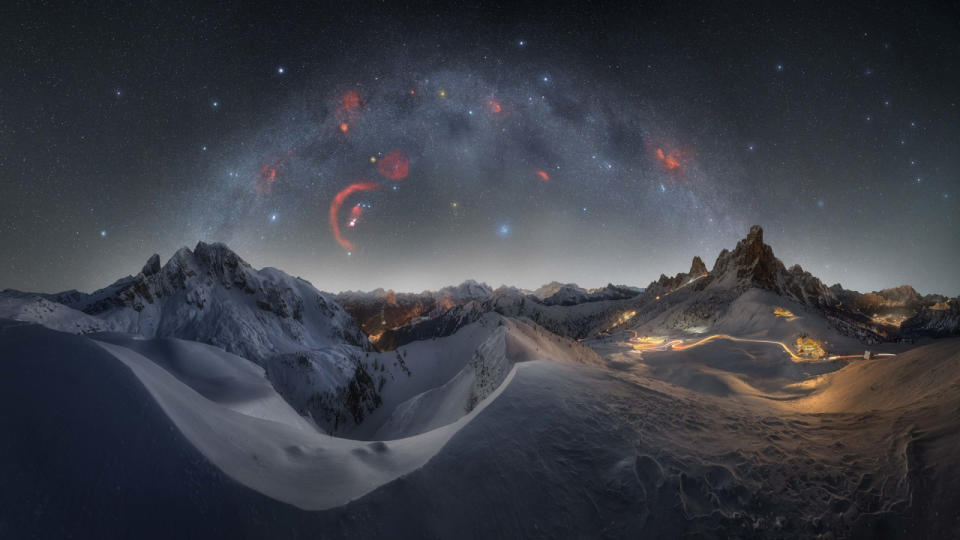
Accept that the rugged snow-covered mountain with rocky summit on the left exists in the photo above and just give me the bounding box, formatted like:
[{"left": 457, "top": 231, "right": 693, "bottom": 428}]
[{"left": 61, "top": 242, "right": 369, "bottom": 365}]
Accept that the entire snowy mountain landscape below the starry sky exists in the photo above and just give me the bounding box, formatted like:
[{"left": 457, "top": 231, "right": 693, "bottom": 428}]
[{"left": 0, "top": 227, "right": 960, "bottom": 539}]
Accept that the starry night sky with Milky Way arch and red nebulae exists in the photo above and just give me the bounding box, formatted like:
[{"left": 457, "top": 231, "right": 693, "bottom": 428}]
[{"left": 0, "top": 2, "right": 960, "bottom": 295}]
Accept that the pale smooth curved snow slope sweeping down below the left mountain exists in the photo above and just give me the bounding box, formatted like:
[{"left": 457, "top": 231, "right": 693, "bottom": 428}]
[{"left": 0, "top": 320, "right": 516, "bottom": 510}]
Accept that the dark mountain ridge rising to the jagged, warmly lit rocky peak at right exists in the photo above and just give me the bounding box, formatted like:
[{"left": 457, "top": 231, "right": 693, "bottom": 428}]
[{"left": 378, "top": 226, "right": 960, "bottom": 350}]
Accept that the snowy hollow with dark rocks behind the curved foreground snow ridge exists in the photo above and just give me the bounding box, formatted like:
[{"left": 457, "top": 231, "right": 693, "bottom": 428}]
[{"left": 256, "top": 313, "right": 601, "bottom": 440}]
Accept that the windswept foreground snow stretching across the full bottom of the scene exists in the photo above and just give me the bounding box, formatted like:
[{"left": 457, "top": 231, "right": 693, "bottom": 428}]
[{"left": 0, "top": 316, "right": 960, "bottom": 538}]
